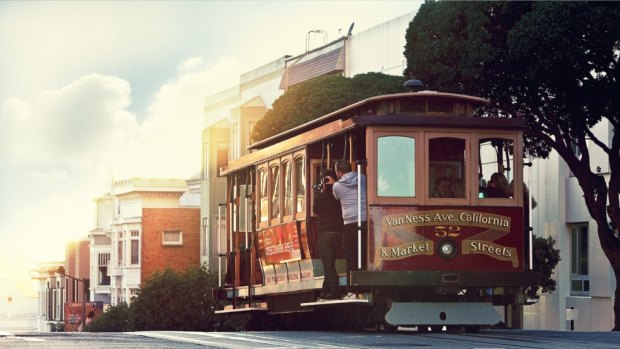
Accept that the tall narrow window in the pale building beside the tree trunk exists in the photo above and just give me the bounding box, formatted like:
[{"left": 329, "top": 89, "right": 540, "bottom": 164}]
[{"left": 570, "top": 224, "right": 590, "bottom": 296}]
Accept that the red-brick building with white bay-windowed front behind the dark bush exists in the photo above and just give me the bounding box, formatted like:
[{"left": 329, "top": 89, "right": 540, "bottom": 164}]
[{"left": 104, "top": 178, "right": 200, "bottom": 305}]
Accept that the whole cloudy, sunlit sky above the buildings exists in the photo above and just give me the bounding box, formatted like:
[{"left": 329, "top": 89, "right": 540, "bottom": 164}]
[{"left": 0, "top": 0, "right": 420, "bottom": 300}]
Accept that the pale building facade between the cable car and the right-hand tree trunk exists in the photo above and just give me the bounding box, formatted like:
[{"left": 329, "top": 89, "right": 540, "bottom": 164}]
[{"left": 524, "top": 122, "right": 616, "bottom": 331}]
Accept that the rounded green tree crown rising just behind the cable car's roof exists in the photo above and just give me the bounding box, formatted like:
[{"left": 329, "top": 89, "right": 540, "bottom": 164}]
[{"left": 252, "top": 73, "right": 405, "bottom": 142}]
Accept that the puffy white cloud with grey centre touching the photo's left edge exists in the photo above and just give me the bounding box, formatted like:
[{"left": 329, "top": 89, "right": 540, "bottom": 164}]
[{"left": 0, "top": 74, "right": 137, "bottom": 167}]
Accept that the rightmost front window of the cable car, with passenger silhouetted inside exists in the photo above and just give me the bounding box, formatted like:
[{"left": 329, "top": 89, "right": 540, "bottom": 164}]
[{"left": 478, "top": 138, "right": 514, "bottom": 198}]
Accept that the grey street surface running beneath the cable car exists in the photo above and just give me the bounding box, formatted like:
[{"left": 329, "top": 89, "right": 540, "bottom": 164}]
[{"left": 0, "top": 330, "right": 620, "bottom": 349}]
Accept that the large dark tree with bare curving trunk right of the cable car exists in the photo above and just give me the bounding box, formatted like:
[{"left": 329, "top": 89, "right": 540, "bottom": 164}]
[{"left": 405, "top": 2, "right": 620, "bottom": 331}]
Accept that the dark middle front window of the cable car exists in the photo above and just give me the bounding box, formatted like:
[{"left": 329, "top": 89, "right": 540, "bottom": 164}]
[{"left": 428, "top": 137, "right": 466, "bottom": 198}]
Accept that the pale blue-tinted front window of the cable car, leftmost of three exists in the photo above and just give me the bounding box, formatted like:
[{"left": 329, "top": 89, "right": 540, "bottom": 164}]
[{"left": 377, "top": 136, "right": 415, "bottom": 197}]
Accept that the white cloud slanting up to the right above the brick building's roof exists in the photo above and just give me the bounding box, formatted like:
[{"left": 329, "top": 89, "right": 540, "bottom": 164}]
[{"left": 114, "top": 57, "right": 240, "bottom": 179}]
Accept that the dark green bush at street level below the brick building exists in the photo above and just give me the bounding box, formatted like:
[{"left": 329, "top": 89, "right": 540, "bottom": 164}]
[{"left": 87, "top": 266, "right": 246, "bottom": 332}]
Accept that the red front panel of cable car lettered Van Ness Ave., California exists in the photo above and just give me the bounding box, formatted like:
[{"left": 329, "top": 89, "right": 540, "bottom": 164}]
[{"left": 369, "top": 206, "right": 523, "bottom": 271}]
